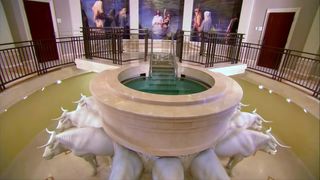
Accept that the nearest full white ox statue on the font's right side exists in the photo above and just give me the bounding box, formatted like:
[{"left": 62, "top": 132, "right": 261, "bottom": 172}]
[{"left": 214, "top": 128, "right": 290, "bottom": 176}]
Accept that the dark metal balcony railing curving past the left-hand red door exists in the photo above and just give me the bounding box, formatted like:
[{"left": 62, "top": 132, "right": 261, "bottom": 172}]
[{"left": 0, "top": 36, "right": 84, "bottom": 91}]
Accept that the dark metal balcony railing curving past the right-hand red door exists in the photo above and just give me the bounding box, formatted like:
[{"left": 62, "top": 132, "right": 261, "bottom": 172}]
[{"left": 239, "top": 43, "right": 320, "bottom": 99}]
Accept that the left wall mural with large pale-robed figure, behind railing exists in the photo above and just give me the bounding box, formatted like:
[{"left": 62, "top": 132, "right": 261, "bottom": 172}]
[{"left": 81, "top": 0, "right": 130, "bottom": 28}]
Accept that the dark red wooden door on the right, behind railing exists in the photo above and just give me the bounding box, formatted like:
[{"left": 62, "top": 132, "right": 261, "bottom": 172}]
[{"left": 258, "top": 12, "right": 295, "bottom": 69}]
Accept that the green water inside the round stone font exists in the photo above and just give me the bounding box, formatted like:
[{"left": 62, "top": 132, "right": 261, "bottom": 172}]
[{"left": 122, "top": 72, "right": 210, "bottom": 95}]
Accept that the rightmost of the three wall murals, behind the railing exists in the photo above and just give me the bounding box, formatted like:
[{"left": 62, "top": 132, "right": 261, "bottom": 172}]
[{"left": 191, "top": 0, "right": 242, "bottom": 39}]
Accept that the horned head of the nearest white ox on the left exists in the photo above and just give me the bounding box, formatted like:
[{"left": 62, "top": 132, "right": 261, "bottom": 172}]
[{"left": 38, "top": 129, "right": 66, "bottom": 160}]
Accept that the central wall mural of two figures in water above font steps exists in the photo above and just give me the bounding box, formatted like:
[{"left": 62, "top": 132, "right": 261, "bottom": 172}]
[{"left": 139, "top": 0, "right": 184, "bottom": 39}]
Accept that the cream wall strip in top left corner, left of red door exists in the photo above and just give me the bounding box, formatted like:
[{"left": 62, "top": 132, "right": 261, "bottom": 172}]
[{"left": 0, "top": 1, "right": 13, "bottom": 44}]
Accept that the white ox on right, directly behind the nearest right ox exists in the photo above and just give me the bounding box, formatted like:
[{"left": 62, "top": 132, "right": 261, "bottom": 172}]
[{"left": 230, "top": 109, "right": 271, "bottom": 131}]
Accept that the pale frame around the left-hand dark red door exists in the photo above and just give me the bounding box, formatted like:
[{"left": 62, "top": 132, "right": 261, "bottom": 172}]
[{"left": 19, "top": 0, "right": 59, "bottom": 40}]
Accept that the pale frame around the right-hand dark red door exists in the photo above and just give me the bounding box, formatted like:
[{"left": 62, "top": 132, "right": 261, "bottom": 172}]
[{"left": 259, "top": 8, "right": 301, "bottom": 49}]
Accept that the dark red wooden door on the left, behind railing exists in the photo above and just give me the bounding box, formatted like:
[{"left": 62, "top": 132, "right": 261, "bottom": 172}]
[{"left": 24, "top": 0, "right": 59, "bottom": 62}]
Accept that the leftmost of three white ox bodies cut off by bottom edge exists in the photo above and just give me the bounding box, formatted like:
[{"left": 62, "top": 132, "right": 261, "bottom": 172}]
[{"left": 109, "top": 143, "right": 143, "bottom": 180}]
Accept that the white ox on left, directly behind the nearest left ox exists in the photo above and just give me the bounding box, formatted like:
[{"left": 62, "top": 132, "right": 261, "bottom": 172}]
[{"left": 54, "top": 108, "right": 103, "bottom": 132}]
